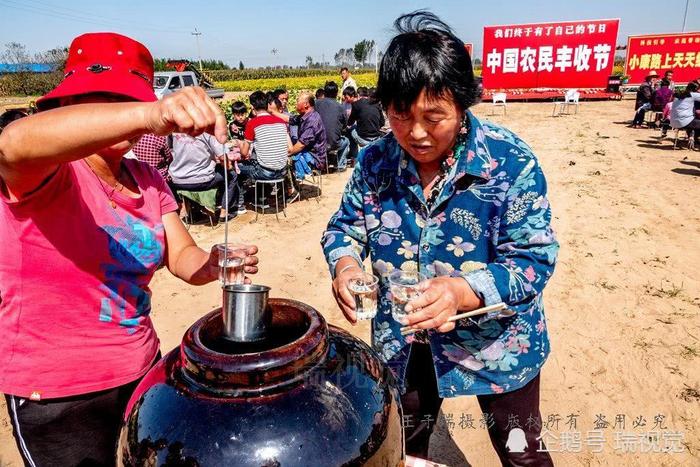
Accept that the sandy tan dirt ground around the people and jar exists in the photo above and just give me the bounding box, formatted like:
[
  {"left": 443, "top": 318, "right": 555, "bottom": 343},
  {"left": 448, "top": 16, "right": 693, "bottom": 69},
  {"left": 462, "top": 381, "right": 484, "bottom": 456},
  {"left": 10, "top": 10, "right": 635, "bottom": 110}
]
[{"left": 0, "top": 101, "right": 700, "bottom": 466}]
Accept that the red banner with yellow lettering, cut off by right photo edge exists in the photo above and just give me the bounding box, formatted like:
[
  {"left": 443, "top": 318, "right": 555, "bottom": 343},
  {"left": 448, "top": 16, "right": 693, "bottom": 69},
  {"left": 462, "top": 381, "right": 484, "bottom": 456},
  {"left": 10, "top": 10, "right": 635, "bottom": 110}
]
[{"left": 625, "top": 32, "right": 700, "bottom": 84}]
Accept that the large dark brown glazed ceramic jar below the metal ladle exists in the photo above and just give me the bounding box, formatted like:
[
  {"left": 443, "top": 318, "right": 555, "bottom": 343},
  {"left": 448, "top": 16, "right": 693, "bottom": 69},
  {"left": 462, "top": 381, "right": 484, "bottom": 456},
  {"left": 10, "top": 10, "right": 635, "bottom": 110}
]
[{"left": 117, "top": 299, "right": 405, "bottom": 467}]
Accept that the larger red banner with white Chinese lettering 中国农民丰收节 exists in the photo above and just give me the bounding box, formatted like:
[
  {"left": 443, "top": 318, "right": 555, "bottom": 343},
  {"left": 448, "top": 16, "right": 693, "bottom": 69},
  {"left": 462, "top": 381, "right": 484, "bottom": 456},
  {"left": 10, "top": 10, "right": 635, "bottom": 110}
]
[{"left": 481, "top": 19, "right": 620, "bottom": 89}]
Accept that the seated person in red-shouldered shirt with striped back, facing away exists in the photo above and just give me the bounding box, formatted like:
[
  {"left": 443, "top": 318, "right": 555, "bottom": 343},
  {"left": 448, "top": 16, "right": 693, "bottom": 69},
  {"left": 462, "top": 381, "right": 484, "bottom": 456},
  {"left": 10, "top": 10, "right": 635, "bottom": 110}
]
[{"left": 239, "top": 91, "right": 297, "bottom": 198}]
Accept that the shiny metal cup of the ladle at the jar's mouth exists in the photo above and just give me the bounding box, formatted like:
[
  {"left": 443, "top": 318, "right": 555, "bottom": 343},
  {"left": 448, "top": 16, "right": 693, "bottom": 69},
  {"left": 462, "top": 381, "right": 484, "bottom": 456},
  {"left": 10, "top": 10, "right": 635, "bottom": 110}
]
[{"left": 222, "top": 284, "right": 272, "bottom": 342}]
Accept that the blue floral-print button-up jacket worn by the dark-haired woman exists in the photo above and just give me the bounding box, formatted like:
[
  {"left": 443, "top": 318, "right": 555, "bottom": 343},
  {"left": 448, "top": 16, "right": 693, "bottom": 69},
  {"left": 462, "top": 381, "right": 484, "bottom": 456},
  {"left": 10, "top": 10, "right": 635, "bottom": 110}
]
[{"left": 322, "top": 112, "right": 559, "bottom": 397}]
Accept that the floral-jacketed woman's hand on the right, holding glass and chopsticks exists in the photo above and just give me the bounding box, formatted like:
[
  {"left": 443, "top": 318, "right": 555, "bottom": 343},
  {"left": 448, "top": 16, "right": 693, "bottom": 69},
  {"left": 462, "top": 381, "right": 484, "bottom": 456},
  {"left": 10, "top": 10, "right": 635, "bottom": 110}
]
[{"left": 406, "top": 277, "right": 483, "bottom": 332}]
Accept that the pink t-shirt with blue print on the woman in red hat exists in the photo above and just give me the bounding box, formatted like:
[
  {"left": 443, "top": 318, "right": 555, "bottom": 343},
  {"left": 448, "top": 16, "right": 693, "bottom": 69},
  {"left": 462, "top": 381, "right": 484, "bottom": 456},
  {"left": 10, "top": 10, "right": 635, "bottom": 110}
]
[{"left": 0, "top": 159, "right": 177, "bottom": 399}]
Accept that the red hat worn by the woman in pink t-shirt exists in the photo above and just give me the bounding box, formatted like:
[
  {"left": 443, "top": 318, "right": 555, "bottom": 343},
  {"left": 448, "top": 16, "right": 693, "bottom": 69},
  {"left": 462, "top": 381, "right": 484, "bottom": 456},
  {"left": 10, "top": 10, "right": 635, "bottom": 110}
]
[{"left": 36, "top": 32, "right": 157, "bottom": 110}]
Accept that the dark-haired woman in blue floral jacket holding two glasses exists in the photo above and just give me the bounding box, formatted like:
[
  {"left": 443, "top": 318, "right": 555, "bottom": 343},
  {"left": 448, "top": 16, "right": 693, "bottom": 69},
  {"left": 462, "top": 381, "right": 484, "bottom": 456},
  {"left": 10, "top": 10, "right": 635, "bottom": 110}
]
[{"left": 322, "top": 12, "right": 558, "bottom": 466}]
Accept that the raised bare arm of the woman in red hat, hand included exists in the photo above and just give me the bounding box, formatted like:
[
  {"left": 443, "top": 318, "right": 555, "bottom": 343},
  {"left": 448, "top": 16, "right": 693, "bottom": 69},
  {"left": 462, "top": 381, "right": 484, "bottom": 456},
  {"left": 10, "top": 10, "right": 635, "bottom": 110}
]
[{"left": 0, "top": 87, "right": 226, "bottom": 199}]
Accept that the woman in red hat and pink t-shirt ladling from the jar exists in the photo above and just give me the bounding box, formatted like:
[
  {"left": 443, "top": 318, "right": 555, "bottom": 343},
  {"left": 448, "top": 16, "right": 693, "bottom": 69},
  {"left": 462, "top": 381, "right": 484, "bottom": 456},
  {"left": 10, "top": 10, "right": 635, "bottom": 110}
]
[{"left": 0, "top": 33, "right": 257, "bottom": 466}]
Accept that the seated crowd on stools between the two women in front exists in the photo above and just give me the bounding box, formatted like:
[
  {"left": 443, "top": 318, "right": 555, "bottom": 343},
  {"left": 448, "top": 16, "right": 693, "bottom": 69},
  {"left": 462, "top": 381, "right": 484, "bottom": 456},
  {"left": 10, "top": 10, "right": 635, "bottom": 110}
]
[{"left": 128, "top": 69, "right": 385, "bottom": 223}]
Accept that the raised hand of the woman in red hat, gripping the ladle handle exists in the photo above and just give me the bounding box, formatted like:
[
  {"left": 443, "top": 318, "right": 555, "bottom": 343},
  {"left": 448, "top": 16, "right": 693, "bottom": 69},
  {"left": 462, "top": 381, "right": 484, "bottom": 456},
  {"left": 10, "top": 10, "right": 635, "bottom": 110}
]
[{"left": 145, "top": 86, "right": 227, "bottom": 144}]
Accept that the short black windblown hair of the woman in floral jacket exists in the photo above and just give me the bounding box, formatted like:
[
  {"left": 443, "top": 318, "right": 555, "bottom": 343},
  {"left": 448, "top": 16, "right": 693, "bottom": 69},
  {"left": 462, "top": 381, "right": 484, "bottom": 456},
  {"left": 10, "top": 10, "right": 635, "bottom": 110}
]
[{"left": 377, "top": 10, "right": 477, "bottom": 112}]
